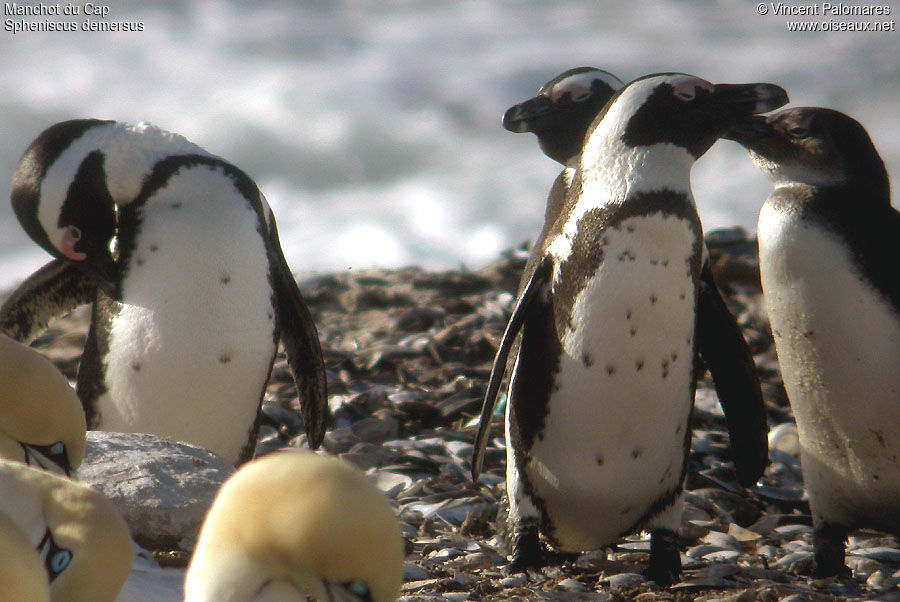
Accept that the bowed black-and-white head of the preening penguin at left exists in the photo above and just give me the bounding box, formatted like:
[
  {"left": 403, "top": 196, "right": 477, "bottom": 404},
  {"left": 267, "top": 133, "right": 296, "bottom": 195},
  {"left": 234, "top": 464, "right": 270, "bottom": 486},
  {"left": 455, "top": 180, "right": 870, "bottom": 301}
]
[{"left": 11, "top": 119, "right": 117, "bottom": 292}]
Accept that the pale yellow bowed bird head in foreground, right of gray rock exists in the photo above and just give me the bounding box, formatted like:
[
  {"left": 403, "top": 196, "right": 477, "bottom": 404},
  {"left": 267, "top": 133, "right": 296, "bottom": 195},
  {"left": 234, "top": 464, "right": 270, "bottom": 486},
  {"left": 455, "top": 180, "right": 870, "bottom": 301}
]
[{"left": 185, "top": 452, "right": 404, "bottom": 602}]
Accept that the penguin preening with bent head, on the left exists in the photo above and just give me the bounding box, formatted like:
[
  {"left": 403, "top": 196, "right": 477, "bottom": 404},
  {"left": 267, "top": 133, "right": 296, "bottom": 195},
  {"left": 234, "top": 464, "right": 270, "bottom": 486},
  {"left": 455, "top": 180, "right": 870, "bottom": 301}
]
[{"left": 0, "top": 119, "right": 327, "bottom": 463}]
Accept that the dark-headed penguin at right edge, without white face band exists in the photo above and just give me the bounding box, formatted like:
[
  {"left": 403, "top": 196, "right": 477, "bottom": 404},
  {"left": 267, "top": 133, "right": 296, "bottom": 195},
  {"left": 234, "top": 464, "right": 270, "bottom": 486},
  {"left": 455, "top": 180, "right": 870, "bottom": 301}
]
[{"left": 727, "top": 107, "right": 900, "bottom": 576}]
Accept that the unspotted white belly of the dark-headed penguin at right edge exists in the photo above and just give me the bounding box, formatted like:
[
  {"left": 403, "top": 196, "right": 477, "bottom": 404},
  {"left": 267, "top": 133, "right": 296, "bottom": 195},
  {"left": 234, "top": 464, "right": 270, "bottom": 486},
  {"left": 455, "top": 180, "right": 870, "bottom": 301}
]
[{"left": 759, "top": 204, "right": 900, "bottom": 532}]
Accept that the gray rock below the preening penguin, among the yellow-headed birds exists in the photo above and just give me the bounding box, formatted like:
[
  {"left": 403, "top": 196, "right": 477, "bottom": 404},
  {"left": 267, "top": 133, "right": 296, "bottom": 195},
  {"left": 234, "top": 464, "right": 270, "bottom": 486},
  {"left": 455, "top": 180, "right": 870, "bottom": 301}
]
[{"left": 78, "top": 431, "right": 234, "bottom": 549}]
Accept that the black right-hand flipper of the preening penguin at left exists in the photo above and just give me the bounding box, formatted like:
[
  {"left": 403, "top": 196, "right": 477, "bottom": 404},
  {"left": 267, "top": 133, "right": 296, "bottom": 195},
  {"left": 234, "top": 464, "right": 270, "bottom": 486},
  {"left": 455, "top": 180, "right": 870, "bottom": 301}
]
[{"left": 269, "top": 215, "right": 328, "bottom": 449}]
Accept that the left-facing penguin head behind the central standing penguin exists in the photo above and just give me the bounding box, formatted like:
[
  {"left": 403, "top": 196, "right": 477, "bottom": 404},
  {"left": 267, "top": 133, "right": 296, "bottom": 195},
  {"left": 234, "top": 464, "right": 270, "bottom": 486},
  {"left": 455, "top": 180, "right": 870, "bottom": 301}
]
[{"left": 503, "top": 67, "right": 622, "bottom": 164}]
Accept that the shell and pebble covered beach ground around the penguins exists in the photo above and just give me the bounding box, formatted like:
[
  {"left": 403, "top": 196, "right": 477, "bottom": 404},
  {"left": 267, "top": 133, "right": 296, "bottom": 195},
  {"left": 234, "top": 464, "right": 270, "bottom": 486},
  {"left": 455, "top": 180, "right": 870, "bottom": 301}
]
[{"left": 4, "top": 229, "right": 900, "bottom": 602}]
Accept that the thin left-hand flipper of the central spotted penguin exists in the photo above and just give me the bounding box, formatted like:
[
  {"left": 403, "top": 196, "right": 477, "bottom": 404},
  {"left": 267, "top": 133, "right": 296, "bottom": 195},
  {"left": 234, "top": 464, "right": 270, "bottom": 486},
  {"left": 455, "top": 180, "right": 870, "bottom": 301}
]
[{"left": 472, "top": 257, "right": 553, "bottom": 480}]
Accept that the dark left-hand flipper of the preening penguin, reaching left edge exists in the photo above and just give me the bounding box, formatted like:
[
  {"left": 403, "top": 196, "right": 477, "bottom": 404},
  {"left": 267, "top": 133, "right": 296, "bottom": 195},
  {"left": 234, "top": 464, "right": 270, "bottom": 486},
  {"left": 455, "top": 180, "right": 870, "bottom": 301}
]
[{"left": 0, "top": 259, "right": 97, "bottom": 343}]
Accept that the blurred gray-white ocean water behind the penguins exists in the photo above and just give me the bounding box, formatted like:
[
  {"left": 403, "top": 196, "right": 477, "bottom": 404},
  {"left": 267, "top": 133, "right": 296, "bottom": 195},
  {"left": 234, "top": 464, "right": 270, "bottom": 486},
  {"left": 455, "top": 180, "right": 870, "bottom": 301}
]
[{"left": 0, "top": 0, "right": 900, "bottom": 288}]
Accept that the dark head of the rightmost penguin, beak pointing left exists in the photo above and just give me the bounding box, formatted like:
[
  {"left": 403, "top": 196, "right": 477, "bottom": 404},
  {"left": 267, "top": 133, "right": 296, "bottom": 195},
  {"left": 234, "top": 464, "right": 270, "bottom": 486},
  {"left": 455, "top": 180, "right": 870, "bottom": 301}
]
[{"left": 725, "top": 107, "right": 889, "bottom": 194}]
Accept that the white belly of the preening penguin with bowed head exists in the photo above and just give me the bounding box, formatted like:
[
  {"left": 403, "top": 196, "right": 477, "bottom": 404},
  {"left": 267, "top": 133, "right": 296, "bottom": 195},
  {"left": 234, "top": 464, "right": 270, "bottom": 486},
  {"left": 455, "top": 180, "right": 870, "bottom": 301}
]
[{"left": 98, "top": 167, "right": 276, "bottom": 462}]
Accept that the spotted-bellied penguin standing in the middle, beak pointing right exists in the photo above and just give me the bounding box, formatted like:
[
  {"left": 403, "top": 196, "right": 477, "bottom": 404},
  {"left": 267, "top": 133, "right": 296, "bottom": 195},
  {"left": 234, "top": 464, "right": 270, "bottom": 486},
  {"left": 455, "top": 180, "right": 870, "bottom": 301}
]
[{"left": 473, "top": 74, "right": 787, "bottom": 584}]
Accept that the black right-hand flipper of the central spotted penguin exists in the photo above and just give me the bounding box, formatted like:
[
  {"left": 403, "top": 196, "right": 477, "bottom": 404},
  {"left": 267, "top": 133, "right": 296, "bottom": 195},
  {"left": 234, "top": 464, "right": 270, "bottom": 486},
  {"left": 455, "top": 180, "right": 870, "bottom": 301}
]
[{"left": 697, "top": 262, "right": 769, "bottom": 487}]
